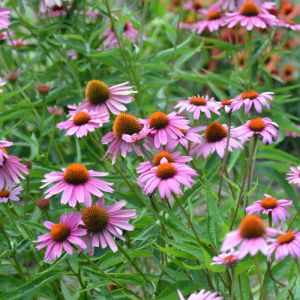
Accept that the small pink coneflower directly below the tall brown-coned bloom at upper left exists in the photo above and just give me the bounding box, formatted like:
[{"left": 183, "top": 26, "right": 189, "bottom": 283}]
[{"left": 57, "top": 109, "right": 109, "bottom": 138}]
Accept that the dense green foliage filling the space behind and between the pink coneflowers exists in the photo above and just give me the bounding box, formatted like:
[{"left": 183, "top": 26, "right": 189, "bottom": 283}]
[{"left": 0, "top": 0, "right": 300, "bottom": 300}]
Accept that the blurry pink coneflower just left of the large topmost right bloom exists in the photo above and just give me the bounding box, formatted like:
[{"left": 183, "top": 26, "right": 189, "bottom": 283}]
[{"left": 197, "top": 5, "right": 226, "bottom": 34}]
